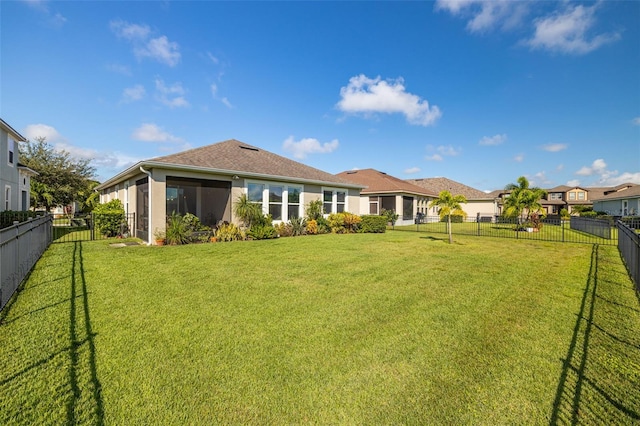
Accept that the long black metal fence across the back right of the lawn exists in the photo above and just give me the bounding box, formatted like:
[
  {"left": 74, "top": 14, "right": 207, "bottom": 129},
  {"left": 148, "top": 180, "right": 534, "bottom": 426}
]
[{"left": 394, "top": 214, "right": 618, "bottom": 245}]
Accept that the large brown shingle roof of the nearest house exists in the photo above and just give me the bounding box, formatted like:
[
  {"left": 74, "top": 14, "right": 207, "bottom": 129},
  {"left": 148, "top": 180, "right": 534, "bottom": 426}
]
[{"left": 97, "top": 139, "right": 362, "bottom": 189}]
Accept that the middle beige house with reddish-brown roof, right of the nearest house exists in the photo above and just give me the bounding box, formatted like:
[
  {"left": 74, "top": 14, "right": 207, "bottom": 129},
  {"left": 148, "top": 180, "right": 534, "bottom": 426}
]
[{"left": 336, "top": 169, "right": 437, "bottom": 225}]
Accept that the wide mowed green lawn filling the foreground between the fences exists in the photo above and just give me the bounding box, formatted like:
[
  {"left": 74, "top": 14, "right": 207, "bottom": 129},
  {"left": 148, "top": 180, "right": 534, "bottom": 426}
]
[{"left": 0, "top": 231, "right": 640, "bottom": 424}]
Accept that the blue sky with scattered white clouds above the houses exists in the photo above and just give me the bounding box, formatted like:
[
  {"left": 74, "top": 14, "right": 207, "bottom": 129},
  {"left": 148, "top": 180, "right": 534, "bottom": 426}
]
[{"left": 0, "top": 0, "right": 640, "bottom": 190}]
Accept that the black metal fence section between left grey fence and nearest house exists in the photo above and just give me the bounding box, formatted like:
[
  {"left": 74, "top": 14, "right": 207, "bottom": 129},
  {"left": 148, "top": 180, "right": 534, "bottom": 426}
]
[{"left": 53, "top": 213, "right": 136, "bottom": 243}]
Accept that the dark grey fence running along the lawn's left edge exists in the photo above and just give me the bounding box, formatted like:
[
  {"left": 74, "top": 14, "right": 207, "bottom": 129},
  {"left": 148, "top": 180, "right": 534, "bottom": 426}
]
[{"left": 0, "top": 215, "right": 52, "bottom": 310}]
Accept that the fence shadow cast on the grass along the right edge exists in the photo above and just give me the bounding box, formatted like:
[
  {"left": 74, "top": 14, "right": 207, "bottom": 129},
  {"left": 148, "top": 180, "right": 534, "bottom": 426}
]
[{"left": 549, "top": 244, "right": 640, "bottom": 425}]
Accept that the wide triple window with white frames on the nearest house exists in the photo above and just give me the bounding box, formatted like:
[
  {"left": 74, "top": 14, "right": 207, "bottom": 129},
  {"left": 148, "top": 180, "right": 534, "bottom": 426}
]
[{"left": 247, "top": 182, "right": 302, "bottom": 221}]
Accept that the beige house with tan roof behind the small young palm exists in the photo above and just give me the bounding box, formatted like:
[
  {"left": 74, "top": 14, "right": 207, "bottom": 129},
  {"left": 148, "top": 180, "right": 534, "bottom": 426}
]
[{"left": 407, "top": 177, "right": 500, "bottom": 220}]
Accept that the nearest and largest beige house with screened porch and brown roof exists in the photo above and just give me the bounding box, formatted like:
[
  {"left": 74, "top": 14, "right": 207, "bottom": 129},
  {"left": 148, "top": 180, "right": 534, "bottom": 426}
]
[{"left": 96, "top": 139, "right": 363, "bottom": 243}]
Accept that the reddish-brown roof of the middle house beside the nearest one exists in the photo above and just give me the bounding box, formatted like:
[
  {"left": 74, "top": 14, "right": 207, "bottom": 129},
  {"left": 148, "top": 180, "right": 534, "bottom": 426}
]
[{"left": 336, "top": 169, "right": 438, "bottom": 197}]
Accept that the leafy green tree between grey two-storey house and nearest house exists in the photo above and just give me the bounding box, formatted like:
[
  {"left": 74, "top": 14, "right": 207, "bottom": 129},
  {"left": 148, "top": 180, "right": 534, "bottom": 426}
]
[{"left": 20, "top": 137, "right": 95, "bottom": 212}]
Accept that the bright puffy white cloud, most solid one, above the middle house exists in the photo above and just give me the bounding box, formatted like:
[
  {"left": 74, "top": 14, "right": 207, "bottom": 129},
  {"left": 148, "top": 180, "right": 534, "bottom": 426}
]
[{"left": 336, "top": 74, "right": 442, "bottom": 126}]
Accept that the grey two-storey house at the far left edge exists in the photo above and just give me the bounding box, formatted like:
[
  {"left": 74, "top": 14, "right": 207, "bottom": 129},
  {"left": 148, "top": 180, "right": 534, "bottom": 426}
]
[{"left": 0, "top": 118, "right": 38, "bottom": 211}]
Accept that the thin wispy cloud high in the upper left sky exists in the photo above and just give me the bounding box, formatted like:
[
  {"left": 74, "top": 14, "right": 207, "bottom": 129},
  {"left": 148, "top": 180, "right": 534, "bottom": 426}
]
[{"left": 109, "top": 20, "right": 181, "bottom": 67}]
